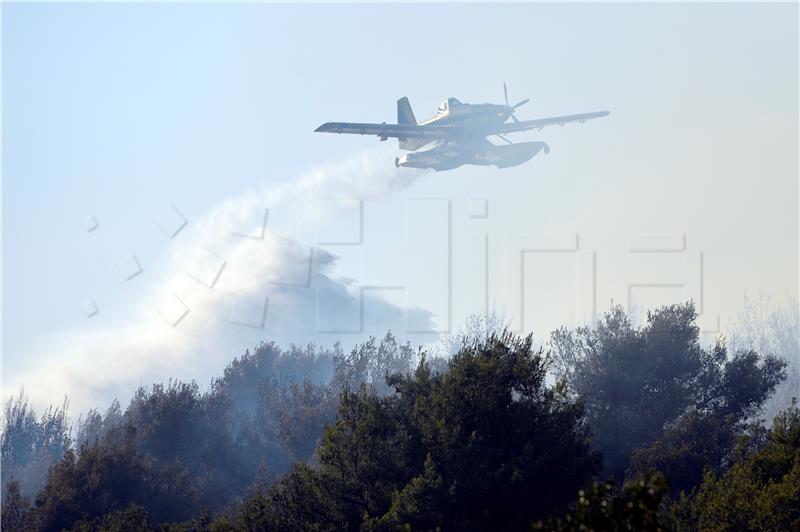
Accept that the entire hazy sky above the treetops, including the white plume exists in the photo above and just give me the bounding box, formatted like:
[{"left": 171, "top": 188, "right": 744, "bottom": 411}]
[{"left": 2, "top": 4, "right": 800, "bottom": 409}]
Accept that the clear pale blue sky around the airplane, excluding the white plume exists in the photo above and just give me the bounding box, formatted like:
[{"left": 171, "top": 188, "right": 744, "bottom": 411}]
[{"left": 2, "top": 4, "right": 798, "bottom": 410}]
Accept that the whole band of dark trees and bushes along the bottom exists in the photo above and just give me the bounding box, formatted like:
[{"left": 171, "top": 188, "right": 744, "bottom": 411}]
[{"left": 2, "top": 303, "right": 800, "bottom": 530}]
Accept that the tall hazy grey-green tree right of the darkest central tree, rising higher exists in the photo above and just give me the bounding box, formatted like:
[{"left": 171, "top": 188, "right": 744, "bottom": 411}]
[{"left": 551, "top": 302, "right": 785, "bottom": 479}]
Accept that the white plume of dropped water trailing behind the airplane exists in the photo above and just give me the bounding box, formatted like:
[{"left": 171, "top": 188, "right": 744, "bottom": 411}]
[{"left": 6, "top": 150, "right": 431, "bottom": 411}]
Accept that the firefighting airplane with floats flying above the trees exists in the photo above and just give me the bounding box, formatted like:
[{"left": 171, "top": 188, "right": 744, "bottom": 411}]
[{"left": 315, "top": 83, "right": 609, "bottom": 171}]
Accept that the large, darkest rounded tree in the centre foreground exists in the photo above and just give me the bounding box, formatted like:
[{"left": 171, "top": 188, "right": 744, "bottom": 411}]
[{"left": 240, "top": 333, "right": 599, "bottom": 530}]
